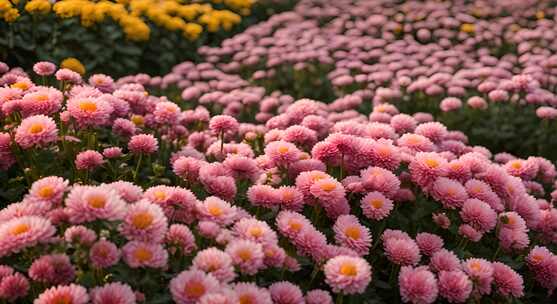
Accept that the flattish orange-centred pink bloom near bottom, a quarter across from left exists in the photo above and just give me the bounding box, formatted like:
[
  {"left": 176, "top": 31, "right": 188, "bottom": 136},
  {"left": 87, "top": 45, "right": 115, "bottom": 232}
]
[{"left": 122, "top": 241, "right": 168, "bottom": 268}]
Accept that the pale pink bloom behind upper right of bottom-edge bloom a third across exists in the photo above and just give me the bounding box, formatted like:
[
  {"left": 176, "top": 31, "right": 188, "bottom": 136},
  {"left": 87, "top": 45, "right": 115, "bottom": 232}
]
[{"left": 192, "top": 247, "right": 236, "bottom": 283}]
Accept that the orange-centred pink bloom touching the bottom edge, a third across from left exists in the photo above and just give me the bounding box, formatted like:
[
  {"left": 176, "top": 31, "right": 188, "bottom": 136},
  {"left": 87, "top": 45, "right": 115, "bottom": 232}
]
[{"left": 169, "top": 270, "right": 220, "bottom": 304}]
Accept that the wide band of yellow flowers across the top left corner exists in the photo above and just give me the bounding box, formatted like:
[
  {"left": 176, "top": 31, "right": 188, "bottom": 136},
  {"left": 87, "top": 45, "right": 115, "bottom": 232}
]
[{"left": 0, "top": 0, "right": 248, "bottom": 41}]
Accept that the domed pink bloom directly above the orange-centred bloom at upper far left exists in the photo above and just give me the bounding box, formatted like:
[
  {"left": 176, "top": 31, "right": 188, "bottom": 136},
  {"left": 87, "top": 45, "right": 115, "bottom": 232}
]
[{"left": 19, "top": 88, "right": 64, "bottom": 117}]
